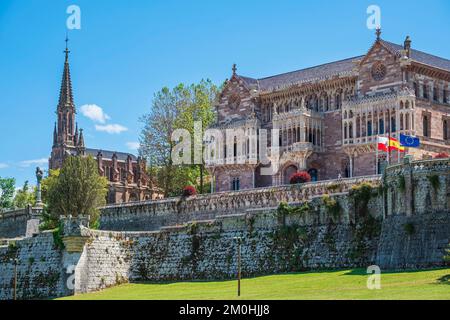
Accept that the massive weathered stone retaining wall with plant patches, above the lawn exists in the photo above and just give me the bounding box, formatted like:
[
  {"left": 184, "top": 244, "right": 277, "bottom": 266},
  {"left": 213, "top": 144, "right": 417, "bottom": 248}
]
[{"left": 0, "top": 158, "right": 450, "bottom": 299}]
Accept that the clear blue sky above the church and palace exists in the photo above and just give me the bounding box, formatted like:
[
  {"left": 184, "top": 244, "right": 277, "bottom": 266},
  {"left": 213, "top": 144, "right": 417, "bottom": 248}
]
[{"left": 0, "top": 0, "right": 450, "bottom": 185}]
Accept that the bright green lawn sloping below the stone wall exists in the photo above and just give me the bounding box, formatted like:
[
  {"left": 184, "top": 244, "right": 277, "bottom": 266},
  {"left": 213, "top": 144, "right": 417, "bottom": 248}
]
[{"left": 60, "top": 268, "right": 450, "bottom": 300}]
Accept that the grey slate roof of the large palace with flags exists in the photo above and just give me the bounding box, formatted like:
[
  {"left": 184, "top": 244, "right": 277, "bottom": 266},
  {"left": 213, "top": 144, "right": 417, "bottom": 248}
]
[{"left": 239, "top": 40, "right": 450, "bottom": 91}]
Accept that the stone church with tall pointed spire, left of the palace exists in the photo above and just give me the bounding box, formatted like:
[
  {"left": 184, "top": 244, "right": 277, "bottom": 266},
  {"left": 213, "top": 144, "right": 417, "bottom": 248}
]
[{"left": 49, "top": 40, "right": 160, "bottom": 204}]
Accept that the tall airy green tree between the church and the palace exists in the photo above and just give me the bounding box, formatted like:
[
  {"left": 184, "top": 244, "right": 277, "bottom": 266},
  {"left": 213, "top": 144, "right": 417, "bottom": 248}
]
[{"left": 140, "top": 80, "right": 218, "bottom": 197}]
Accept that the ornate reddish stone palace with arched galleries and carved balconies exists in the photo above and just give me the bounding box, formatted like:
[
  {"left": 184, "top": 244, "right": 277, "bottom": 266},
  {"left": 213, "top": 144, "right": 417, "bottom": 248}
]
[{"left": 206, "top": 30, "right": 450, "bottom": 191}]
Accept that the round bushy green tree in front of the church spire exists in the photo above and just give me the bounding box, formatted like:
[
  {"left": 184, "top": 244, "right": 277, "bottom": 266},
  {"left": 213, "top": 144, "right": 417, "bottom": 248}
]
[{"left": 46, "top": 156, "right": 108, "bottom": 223}]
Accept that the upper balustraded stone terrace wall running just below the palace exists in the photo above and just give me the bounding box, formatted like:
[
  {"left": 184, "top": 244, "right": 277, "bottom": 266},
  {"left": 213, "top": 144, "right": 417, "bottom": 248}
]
[{"left": 100, "top": 176, "right": 380, "bottom": 231}]
